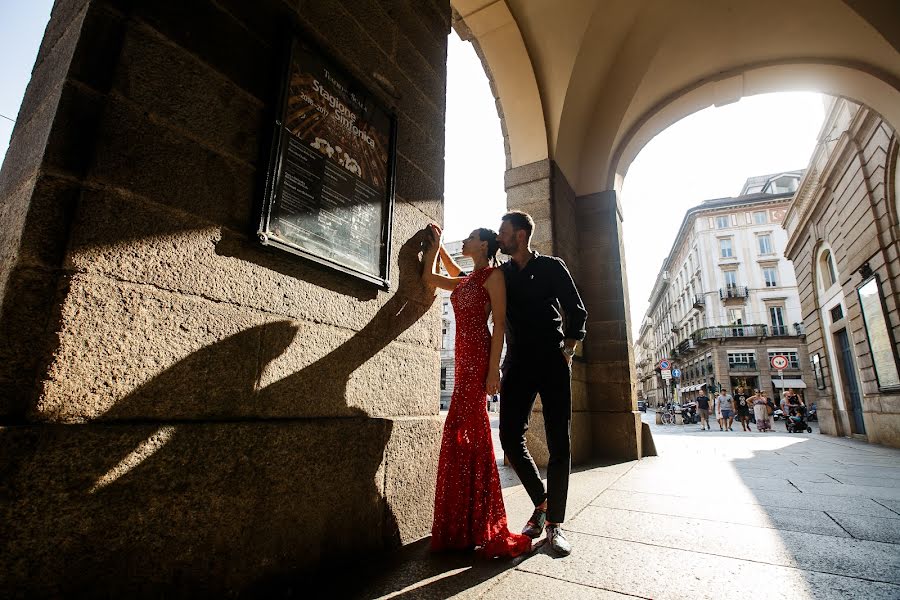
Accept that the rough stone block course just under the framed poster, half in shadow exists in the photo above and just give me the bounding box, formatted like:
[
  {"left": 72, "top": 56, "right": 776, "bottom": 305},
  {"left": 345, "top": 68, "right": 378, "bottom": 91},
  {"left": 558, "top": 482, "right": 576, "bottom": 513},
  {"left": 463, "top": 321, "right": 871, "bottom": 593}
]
[{"left": 67, "top": 185, "right": 439, "bottom": 348}]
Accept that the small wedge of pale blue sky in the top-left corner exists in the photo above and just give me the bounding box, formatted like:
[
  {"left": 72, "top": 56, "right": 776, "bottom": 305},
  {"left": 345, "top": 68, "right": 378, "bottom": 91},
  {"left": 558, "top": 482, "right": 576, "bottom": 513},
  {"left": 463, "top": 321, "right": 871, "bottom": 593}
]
[{"left": 0, "top": 0, "right": 53, "bottom": 164}]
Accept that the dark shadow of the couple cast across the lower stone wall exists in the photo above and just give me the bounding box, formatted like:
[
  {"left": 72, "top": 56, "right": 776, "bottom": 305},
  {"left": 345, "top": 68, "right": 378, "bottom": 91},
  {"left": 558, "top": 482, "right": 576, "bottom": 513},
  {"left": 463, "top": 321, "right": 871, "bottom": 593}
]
[{"left": 0, "top": 233, "right": 431, "bottom": 596}]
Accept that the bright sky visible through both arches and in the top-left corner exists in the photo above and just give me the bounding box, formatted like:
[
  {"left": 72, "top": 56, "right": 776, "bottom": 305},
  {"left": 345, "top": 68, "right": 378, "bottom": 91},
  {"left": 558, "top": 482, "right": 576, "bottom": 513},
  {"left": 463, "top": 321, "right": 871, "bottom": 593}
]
[{"left": 0, "top": 14, "right": 824, "bottom": 336}]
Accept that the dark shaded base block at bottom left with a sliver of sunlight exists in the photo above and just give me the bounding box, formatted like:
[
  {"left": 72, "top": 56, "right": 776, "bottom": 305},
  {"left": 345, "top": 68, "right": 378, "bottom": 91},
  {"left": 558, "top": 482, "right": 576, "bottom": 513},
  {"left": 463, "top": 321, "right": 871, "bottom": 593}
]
[{"left": 0, "top": 419, "right": 404, "bottom": 596}]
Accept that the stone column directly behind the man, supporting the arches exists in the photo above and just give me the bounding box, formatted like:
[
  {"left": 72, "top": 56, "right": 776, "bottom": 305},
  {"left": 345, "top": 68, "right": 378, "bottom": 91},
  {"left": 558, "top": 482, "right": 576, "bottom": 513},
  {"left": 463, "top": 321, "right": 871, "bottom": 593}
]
[{"left": 506, "top": 169, "right": 642, "bottom": 465}]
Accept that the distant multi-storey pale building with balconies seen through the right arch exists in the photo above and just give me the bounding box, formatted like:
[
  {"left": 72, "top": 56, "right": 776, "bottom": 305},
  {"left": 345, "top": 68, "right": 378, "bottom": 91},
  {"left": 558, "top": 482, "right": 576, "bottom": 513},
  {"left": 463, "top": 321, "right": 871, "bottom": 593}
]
[{"left": 641, "top": 178, "right": 812, "bottom": 402}]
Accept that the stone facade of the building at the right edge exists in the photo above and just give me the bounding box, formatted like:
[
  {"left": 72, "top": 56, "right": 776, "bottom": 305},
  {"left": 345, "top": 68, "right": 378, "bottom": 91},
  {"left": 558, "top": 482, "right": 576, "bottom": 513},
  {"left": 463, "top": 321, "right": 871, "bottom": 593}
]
[{"left": 789, "top": 107, "right": 900, "bottom": 447}]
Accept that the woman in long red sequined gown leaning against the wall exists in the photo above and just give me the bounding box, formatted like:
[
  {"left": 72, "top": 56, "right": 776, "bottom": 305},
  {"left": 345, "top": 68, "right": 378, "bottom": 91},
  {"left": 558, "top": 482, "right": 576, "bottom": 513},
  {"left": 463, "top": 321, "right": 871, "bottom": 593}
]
[{"left": 423, "top": 225, "right": 531, "bottom": 557}]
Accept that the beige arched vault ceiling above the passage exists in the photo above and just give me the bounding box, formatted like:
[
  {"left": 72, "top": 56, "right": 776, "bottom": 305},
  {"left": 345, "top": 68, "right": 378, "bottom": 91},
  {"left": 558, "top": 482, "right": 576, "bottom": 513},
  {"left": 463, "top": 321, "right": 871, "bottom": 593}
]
[{"left": 451, "top": 0, "right": 900, "bottom": 195}]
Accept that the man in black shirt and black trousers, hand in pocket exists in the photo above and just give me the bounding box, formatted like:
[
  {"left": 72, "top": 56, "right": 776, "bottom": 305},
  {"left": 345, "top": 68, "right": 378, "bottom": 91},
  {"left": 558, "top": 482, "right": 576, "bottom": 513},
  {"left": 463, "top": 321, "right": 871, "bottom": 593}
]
[{"left": 497, "top": 211, "right": 587, "bottom": 555}]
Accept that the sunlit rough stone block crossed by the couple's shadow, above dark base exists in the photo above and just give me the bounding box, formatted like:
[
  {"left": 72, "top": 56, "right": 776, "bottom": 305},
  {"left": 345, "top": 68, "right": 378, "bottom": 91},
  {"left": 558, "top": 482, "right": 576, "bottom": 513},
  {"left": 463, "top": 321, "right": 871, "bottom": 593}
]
[{"left": 34, "top": 276, "right": 439, "bottom": 422}]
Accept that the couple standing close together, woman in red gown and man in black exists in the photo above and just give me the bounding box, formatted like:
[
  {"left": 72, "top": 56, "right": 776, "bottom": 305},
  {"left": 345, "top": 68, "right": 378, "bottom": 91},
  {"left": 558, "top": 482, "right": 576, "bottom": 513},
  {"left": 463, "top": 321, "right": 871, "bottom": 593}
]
[{"left": 423, "top": 211, "right": 587, "bottom": 557}]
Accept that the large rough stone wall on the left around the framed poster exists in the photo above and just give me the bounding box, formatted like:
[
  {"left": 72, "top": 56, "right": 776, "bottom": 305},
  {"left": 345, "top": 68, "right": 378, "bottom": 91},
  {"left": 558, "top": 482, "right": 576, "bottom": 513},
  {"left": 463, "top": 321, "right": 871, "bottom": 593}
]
[{"left": 0, "top": 0, "right": 450, "bottom": 595}]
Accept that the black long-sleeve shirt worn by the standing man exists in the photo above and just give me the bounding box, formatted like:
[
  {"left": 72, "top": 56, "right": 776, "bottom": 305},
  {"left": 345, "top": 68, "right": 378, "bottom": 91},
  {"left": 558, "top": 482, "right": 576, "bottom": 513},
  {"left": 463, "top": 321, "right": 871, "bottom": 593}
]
[{"left": 500, "top": 252, "right": 587, "bottom": 360}]
